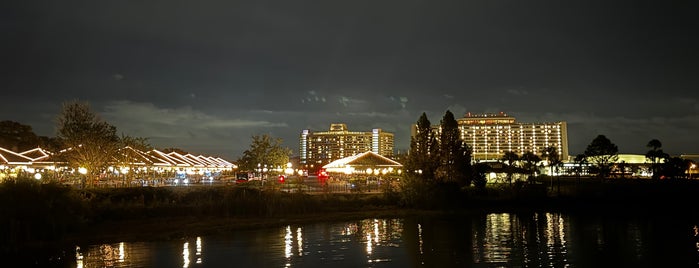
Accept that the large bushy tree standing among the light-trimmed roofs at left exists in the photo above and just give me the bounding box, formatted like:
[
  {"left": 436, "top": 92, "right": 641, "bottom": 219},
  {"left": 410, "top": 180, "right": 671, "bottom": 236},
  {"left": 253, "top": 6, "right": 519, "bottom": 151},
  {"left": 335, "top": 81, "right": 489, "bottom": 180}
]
[{"left": 56, "top": 101, "right": 119, "bottom": 186}]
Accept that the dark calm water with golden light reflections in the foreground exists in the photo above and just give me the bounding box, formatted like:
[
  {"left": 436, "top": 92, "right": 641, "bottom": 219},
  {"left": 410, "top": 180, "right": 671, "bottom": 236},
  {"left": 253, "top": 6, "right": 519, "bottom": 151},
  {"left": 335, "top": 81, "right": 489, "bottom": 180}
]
[{"left": 45, "top": 213, "right": 699, "bottom": 267}]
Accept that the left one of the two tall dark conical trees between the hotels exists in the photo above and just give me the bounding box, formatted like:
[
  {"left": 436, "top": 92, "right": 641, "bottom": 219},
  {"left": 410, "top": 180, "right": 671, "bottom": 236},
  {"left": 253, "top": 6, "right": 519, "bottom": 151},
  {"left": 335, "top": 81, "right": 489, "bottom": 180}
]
[{"left": 405, "top": 113, "right": 439, "bottom": 179}]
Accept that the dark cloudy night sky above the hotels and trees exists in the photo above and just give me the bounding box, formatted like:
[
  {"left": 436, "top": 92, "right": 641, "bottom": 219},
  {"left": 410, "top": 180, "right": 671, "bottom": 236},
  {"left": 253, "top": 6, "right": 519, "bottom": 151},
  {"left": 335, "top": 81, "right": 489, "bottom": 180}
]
[{"left": 0, "top": 0, "right": 699, "bottom": 160}]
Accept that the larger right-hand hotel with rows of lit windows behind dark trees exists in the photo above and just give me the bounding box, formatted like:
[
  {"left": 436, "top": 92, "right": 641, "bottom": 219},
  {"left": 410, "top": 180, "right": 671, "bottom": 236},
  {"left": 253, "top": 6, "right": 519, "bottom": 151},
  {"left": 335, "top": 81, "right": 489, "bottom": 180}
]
[{"left": 413, "top": 112, "right": 569, "bottom": 161}]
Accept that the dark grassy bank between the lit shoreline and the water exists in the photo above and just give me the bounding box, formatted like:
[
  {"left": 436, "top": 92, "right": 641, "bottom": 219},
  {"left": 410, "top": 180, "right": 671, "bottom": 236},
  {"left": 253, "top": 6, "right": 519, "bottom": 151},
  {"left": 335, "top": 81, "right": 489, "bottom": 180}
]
[{"left": 0, "top": 177, "right": 699, "bottom": 255}]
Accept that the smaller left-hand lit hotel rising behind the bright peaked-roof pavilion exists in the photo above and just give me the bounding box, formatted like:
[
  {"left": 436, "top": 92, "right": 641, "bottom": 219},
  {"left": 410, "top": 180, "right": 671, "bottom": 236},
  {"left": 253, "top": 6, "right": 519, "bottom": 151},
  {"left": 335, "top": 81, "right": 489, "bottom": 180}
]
[{"left": 299, "top": 124, "right": 393, "bottom": 167}]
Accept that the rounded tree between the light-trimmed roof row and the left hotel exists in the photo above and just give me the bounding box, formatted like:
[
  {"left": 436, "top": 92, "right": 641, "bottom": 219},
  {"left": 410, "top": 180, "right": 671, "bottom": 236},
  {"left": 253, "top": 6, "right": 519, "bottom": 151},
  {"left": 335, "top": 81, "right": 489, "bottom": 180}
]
[{"left": 238, "top": 134, "right": 291, "bottom": 170}]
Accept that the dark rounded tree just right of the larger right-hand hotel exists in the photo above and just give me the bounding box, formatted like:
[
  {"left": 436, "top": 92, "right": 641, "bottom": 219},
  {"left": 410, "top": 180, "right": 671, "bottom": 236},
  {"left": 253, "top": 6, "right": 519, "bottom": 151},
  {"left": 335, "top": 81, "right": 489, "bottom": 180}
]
[{"left": 585, "top": 135, "right": 619, "bottom": 179}]
